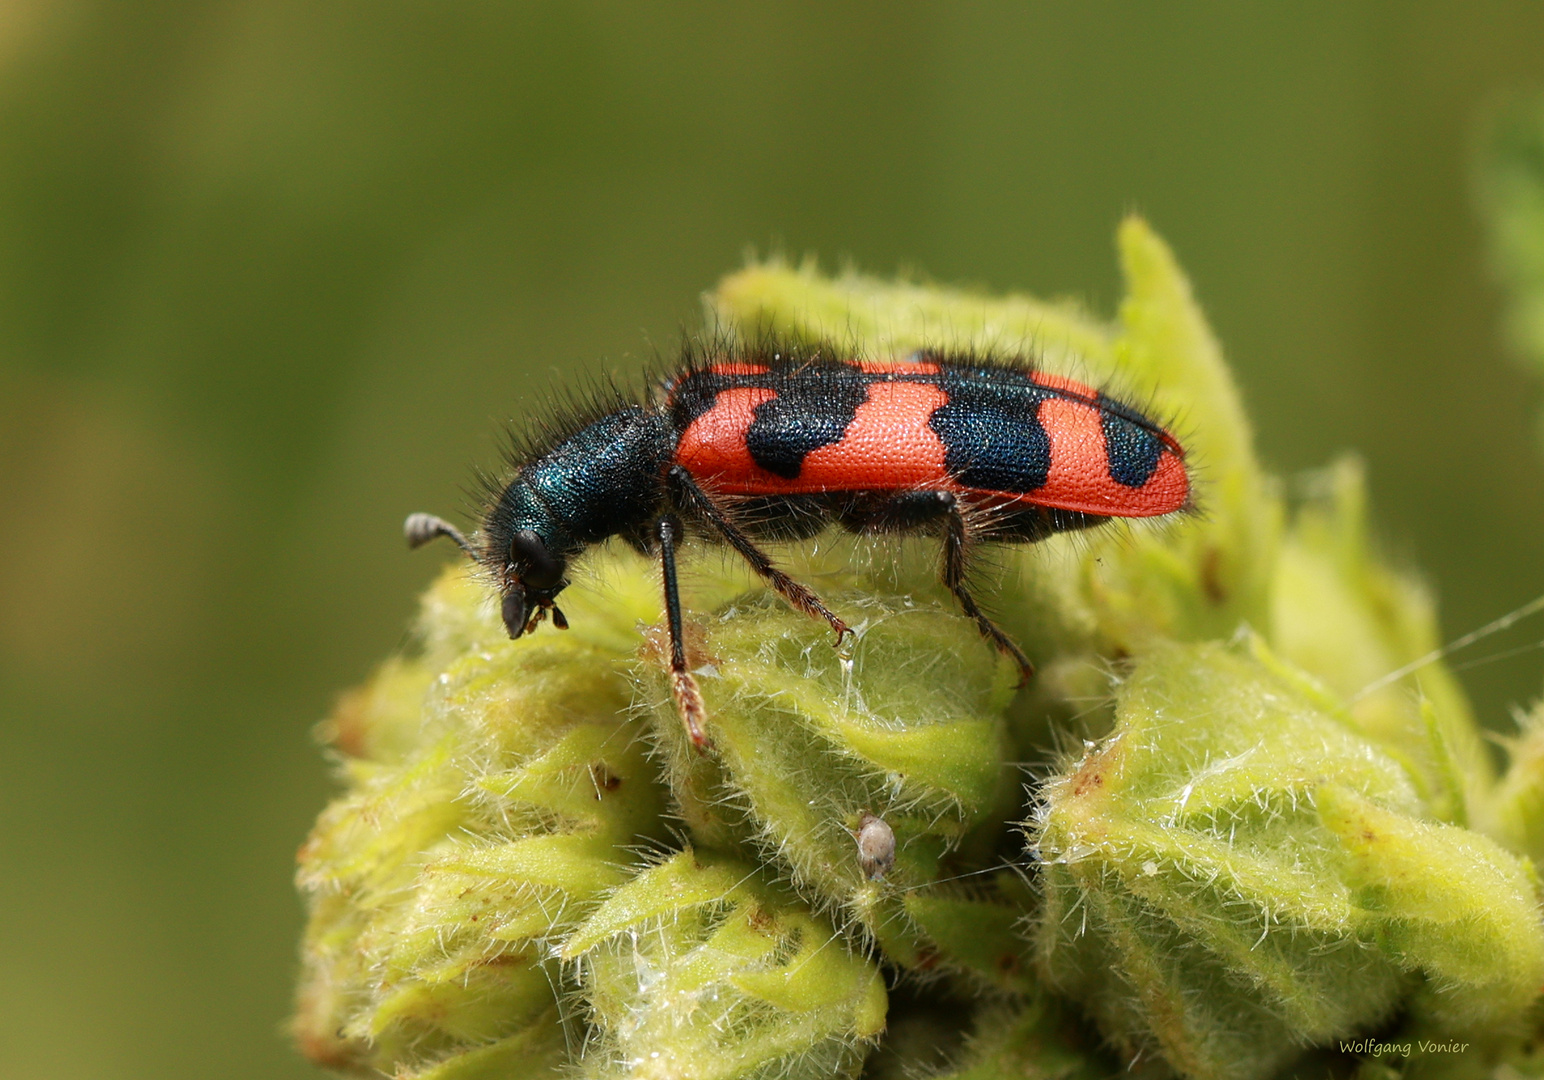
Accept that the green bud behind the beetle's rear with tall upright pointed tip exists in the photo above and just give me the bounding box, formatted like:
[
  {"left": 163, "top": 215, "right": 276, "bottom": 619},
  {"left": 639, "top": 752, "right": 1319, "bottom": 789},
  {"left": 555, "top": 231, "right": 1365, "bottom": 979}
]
[{"left": 709, "top": 218, "right": 1282, "bottom": 745}]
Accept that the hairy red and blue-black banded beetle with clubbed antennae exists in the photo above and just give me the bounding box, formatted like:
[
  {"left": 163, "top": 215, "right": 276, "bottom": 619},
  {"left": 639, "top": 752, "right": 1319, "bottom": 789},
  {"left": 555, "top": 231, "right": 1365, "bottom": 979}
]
[{"left": 405, "top": 333, "right": 1190, "bottom": 748}]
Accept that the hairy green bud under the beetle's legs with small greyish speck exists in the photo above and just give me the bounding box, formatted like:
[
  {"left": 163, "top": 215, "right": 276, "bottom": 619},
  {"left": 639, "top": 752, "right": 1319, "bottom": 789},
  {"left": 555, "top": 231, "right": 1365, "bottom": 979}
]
[{"left": 639, "top": 592, "right": 1021, "bottom": 984}]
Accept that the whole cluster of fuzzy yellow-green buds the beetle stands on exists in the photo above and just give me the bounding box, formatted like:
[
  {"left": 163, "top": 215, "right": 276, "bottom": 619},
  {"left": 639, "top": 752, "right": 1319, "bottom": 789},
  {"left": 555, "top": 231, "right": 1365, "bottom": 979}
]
[{"left": 293, "top": 218, "right": 1544, "bottom": 1080}]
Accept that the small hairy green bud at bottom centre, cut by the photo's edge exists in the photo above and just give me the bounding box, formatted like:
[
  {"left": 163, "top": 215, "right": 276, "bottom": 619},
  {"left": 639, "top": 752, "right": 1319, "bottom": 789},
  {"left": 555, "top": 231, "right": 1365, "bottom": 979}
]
[{"left": 562, "top": 850, "right": 886, "bottom": 1080}]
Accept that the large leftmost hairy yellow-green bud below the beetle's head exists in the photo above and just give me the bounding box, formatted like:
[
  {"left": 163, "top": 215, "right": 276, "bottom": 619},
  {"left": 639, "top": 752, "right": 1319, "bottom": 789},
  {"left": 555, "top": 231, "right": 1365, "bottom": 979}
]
[{"left": 295, "top": 569, "right": 662, "bottom": 1075}]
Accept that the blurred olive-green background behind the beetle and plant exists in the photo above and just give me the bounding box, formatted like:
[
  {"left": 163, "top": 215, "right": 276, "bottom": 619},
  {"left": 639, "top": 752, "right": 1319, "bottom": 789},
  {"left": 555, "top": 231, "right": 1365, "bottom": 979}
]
[{"left": 0, "top": 0, "right": 1544, "bottom": 1080}]
